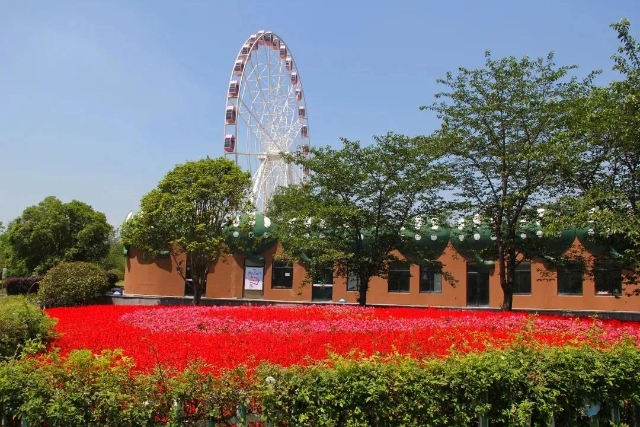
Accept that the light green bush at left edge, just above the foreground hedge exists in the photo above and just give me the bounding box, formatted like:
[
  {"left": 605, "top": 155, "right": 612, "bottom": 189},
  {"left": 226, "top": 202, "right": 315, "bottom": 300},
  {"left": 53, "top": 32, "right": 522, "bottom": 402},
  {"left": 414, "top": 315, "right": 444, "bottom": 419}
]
[{"left": 0, "top": 296, "right": 56, "bottom": 361}]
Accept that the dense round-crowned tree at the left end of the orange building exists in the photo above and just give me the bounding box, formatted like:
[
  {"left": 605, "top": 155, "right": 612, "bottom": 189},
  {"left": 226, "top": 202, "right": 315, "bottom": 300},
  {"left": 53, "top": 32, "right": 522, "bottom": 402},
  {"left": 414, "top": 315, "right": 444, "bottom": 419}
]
[{"left": 121, "top": 157, "right": 251, "bottom": 304}]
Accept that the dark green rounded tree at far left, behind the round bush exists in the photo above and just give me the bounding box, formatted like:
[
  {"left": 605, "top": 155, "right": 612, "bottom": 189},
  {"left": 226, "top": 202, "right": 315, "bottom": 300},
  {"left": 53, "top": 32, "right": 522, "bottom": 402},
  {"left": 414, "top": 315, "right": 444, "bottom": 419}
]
[{"left": 6, "top": 196, "right": 112, "bottom": 274}]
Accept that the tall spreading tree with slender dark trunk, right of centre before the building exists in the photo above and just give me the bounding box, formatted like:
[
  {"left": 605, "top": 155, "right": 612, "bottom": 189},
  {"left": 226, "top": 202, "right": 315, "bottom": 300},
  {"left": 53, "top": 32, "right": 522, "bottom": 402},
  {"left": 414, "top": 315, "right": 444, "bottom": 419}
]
[{"left": 421, "top": 52, "right": 593, "bottom": 310}]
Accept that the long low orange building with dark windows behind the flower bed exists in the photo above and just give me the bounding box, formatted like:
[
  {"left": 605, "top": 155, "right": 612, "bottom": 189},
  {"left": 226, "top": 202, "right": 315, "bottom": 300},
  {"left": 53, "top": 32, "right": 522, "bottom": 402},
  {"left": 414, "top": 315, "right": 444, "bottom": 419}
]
[{"left": 124, "top": 214, "right": 640, "bottom": 312}]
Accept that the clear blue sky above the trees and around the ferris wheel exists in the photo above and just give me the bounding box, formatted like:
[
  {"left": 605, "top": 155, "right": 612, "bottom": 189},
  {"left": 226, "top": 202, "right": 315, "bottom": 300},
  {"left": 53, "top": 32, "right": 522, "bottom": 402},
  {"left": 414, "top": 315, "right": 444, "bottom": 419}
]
[{"left": 0, "top": 0, "right": 640, "bottom": 231}]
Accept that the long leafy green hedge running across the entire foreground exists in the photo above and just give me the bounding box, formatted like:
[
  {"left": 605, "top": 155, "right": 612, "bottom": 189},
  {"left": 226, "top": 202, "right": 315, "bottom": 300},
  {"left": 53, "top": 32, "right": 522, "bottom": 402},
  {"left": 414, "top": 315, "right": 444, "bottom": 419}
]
[{"left": 0, "top": 342, "right": 640, "bottom": 427}]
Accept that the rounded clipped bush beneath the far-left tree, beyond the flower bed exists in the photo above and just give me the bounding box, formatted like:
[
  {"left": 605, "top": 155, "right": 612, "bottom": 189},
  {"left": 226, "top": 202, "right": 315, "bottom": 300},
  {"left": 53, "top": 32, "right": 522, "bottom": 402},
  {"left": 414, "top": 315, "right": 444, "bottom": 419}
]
[{"left": 38, "top": 262, "right": 109, "bottom": 307}]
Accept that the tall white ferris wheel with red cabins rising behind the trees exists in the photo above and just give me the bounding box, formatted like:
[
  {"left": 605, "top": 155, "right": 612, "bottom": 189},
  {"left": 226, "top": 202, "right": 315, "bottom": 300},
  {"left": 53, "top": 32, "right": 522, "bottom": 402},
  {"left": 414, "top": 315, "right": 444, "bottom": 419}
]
[{"left": 224, "top": 31, "right": 309, "bottom": 212}]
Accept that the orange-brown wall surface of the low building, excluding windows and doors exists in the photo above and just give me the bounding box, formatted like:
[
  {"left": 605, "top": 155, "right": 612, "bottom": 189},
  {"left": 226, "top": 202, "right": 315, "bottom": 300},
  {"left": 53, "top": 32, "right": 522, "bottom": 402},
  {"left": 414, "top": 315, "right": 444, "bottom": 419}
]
[{"left": 124, "top": 240, "right": 640, "bottom": 311}]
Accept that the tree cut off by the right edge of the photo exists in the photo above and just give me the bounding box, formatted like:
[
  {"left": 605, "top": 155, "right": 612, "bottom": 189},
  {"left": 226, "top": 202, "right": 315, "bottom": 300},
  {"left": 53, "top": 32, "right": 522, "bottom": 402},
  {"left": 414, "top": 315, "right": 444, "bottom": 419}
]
[{"left": 553, "top": 19, "right": 640, "bottom": 269}]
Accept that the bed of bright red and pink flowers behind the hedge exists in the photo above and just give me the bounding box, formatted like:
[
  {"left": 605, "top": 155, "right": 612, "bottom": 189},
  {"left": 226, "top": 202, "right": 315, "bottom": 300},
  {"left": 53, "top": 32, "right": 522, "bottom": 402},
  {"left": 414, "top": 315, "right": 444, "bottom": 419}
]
[{"left": 47, "top": 305, "right": 640, "bottom": 371}]
